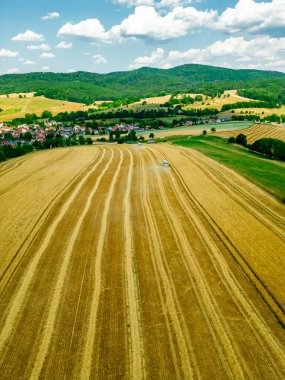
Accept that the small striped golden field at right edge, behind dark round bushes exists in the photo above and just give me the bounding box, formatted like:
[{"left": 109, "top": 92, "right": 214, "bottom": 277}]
[{"left": 217, "top": 124, "right": 285, "bottom": 144}]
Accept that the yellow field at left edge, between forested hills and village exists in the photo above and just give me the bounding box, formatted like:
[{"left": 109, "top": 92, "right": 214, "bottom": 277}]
[{"left": 0, "top": 93, "right": 91, "bottom": 121}]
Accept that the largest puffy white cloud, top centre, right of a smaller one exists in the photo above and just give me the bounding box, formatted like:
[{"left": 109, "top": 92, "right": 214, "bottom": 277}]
[{"left": 111, "top": 6, "right": 217, "bottom": 41}]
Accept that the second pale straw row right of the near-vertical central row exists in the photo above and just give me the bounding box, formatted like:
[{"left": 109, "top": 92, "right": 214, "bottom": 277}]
[{"left": 146, "top": 149, "right": 246, "bottom": 379}]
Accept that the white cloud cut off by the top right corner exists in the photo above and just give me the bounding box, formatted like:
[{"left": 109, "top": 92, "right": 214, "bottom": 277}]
[{"left": 216, "top": 0, "right": 285, "bottom": 34}]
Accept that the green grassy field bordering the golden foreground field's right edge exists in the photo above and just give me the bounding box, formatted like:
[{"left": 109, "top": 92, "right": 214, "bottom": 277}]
[{"left": 171, "top": 136, "right": 285, "bottom": 202}]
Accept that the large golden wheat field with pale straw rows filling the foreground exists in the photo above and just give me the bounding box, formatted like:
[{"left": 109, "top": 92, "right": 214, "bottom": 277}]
[{"left": 0, "top": 144, "right": 285, "bottom": 380}]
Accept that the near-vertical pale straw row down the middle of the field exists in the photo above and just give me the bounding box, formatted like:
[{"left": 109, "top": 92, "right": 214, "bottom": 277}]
[{"left": 124, "top": 151, "right": 145, "bottom": 380}]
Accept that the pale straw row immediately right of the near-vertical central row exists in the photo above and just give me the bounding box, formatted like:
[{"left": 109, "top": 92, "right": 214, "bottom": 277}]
[{"left": 136, "top": 150, "right": 194, "bottom": 379}]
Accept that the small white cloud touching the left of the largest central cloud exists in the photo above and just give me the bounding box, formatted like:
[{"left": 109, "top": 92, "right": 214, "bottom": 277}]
[{"left": 57, "top": 18, "right": 110, "bottom": 42}]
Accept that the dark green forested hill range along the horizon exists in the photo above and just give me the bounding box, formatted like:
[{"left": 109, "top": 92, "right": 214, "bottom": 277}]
[{"left": 0, "top": 64, "right": 285, "bottom": 104}]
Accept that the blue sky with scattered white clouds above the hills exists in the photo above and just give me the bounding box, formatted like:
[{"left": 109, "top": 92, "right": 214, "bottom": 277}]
[{"left": 0, "top": 0, "right": 285, "bottom": 74}]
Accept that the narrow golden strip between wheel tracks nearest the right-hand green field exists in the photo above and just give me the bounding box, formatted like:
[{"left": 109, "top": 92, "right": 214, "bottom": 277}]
[{"left": 182, "top": 151, "right": 285, "bottom": 240}]
